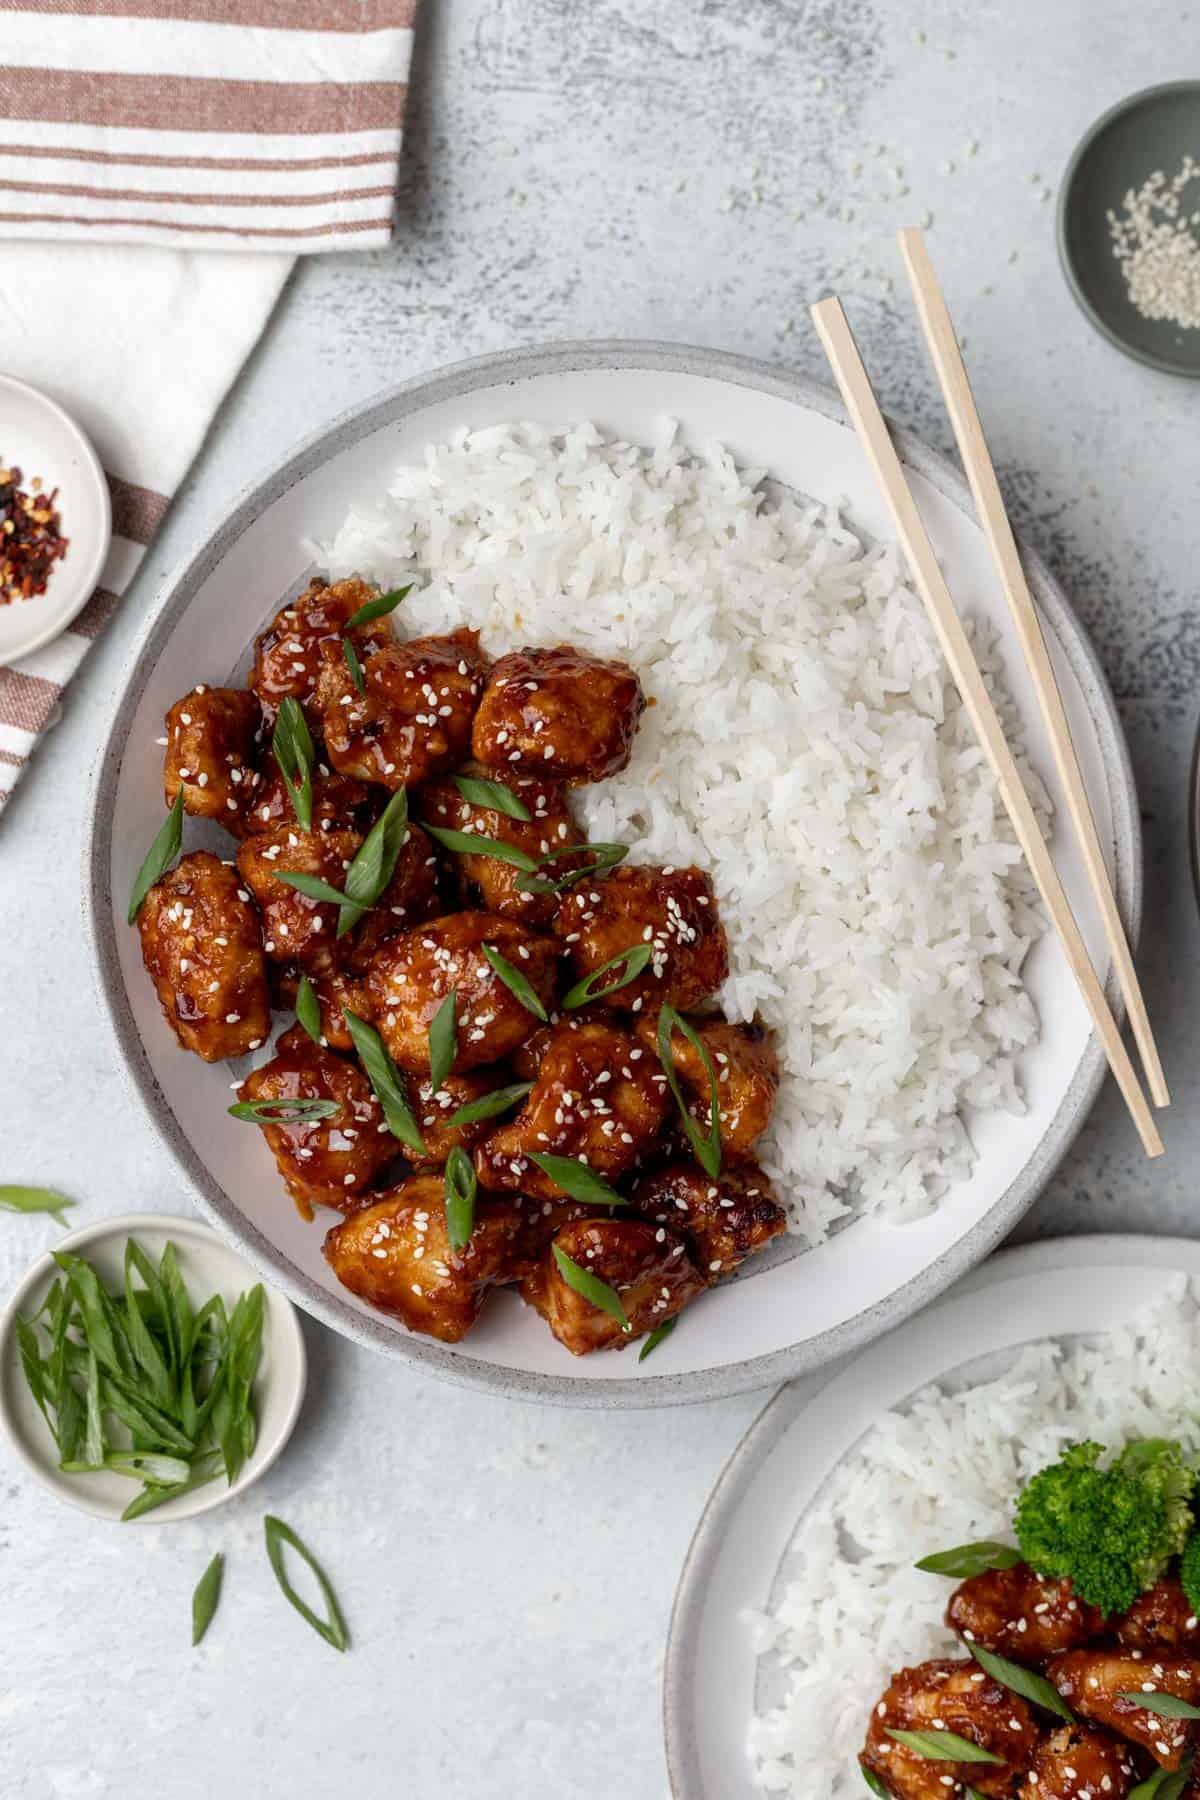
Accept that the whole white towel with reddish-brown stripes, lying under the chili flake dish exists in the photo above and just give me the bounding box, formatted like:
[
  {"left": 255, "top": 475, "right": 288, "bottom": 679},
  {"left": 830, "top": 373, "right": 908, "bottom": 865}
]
[{"left": 0, "top": 0, "right": 422, "bottom": 806}]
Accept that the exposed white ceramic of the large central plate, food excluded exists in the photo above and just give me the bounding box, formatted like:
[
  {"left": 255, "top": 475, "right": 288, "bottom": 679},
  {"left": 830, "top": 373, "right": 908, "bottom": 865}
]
[{"left": 86, "top": 344, "right": 1141, "bottom": 1406}]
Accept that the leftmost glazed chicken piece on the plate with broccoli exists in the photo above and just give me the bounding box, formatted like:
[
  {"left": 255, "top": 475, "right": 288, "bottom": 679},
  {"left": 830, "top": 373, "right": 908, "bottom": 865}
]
[{"left": 858, "top": 1658, "right": 1038, "bottom": 1800}]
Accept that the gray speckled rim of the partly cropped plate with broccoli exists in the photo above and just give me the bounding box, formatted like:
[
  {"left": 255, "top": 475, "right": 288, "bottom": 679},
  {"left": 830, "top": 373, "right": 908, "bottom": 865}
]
[{"left": 662, "top": 1231, "right": 1200, "bottom": 1800}]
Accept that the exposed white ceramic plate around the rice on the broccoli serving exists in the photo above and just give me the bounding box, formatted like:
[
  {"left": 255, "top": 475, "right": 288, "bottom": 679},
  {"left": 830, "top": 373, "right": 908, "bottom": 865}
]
[{"left": 664, "top": 1237, "right": 1200, "bottom": 1800}]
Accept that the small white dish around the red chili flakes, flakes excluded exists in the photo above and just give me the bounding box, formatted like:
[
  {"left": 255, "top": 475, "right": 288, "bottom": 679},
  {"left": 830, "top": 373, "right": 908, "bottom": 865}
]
[{"left": 0, "top": 374, "right": 113, "bottom": 662}]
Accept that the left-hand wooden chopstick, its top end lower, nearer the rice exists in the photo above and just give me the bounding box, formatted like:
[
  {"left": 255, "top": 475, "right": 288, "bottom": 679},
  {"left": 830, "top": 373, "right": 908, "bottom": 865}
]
[{"left": 811, "top": 297, "right": 1162, "bottom": 1156}]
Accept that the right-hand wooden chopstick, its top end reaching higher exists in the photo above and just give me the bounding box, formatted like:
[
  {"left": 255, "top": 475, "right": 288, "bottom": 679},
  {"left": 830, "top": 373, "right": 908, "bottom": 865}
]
[{"left": 900, "top": 227, "right": 1171, "bottom": 1107}]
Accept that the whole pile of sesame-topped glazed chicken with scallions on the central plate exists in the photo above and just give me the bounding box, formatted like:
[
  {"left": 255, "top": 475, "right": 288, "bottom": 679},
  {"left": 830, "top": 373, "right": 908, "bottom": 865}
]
[{"left": 137, "top": 580, "right": 788, "bottom": 1353}]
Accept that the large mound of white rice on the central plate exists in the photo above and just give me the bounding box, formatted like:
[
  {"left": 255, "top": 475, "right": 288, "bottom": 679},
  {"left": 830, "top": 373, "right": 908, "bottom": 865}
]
[{"left": 315, "top": 421, "right": 1043, "bottom": 1244}]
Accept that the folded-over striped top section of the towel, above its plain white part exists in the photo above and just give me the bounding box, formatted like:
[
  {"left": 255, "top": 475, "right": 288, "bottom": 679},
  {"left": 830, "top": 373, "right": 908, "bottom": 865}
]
[{"left": 0, "top": 0, "right": 416, "bottom": 254}]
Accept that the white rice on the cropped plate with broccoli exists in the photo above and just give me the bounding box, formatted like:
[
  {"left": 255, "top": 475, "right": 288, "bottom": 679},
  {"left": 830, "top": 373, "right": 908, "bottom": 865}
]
[{"left": 748, "top": 1274, "right": 1200, "bottom": 1800}]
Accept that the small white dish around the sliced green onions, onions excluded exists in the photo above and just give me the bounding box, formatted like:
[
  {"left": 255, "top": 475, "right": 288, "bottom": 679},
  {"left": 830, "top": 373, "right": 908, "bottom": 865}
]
[{"left": 0, "top": 1213, "right": 308, "bottom": 1525}]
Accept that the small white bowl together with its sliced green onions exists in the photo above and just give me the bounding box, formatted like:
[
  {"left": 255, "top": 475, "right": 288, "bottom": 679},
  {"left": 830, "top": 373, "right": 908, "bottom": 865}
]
[{"left": 0, "top": 1213, "right": 306, "bottom": 1523}]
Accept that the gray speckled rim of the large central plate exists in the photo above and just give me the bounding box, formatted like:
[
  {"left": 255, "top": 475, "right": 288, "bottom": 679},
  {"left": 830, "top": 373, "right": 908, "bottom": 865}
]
[{"left": 83, "top": 340, "right": 1142, "bottom": 1409}]
